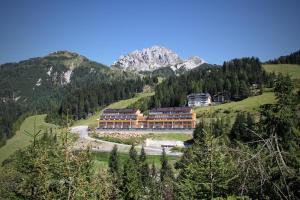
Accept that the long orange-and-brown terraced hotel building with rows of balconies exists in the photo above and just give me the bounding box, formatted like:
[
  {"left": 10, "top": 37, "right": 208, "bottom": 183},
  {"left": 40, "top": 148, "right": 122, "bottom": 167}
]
[{"left": 98, "top": 107, "right": 196, "bottom": 129}]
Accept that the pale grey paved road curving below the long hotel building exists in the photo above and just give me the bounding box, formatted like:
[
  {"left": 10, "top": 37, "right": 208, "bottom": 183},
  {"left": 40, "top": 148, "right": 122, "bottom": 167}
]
[{"left": 70, "top": 126, "right": 182, "bottom": 156}]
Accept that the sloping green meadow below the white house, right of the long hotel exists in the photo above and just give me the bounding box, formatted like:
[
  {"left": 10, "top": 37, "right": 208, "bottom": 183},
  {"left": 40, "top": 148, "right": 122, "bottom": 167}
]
[{"left": 195, "top": 92, "right": 276, "bottom": 121}]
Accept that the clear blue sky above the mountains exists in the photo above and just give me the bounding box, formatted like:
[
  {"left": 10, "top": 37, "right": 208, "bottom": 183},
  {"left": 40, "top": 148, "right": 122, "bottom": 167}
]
[{"left": 0, "top": 0, "right": 300, "bottom": 65}]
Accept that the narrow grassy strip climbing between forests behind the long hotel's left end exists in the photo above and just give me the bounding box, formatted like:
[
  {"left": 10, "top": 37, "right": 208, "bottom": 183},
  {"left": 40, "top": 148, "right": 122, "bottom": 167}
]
[{"left": 74, "top": 92, "right": 154, "bottom": 127}]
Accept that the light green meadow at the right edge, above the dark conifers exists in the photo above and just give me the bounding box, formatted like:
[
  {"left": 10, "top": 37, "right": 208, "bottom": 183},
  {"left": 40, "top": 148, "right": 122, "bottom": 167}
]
[{"left": 263, "top": 64, "right": 300, "bottom": 79}]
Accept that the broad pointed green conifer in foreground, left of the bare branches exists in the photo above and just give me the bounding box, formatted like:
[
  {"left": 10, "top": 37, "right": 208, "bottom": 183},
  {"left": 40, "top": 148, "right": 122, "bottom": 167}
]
[{"left": 175, "top": 132, "right": 234, "bottom": 200}]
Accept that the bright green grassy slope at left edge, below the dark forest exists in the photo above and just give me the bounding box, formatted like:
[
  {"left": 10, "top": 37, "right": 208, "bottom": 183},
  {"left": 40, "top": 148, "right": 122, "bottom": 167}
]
[{"left": 0, "top": 115, "right": 55, "bottom": 163}]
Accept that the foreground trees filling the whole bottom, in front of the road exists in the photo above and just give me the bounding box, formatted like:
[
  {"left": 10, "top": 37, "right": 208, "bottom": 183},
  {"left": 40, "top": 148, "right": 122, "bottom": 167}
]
[{"left": 0, "top": 75, "right": 300, "bottom": 200}]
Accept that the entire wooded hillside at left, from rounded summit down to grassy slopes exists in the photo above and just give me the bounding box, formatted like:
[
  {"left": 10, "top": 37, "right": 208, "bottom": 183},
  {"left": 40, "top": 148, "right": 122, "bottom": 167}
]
[{"left": 0, "top": 51, "right": 144, "bottom": 146}]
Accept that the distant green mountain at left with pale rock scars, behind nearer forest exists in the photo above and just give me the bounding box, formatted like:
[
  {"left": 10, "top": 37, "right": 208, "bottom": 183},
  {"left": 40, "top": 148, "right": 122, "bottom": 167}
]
[{"left": 0, "top": 51, "right": 112, "bottom": 101}]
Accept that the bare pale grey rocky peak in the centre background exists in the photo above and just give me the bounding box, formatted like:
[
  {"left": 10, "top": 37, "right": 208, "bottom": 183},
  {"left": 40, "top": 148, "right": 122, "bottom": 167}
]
[{"left": 112, "top": 46, "right": 205, "bottom": 72}]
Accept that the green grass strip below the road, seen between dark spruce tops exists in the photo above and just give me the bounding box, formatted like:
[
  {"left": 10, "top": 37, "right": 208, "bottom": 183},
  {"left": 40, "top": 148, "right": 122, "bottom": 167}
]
[{"left": 92, "top": 152, "right": 180, "bottom": 169}]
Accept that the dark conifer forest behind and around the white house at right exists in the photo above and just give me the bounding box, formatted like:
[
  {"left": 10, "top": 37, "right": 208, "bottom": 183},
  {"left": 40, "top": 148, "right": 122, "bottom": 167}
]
[{"left": 148, "top": 57, "right": 275, "bottom": 110}]
